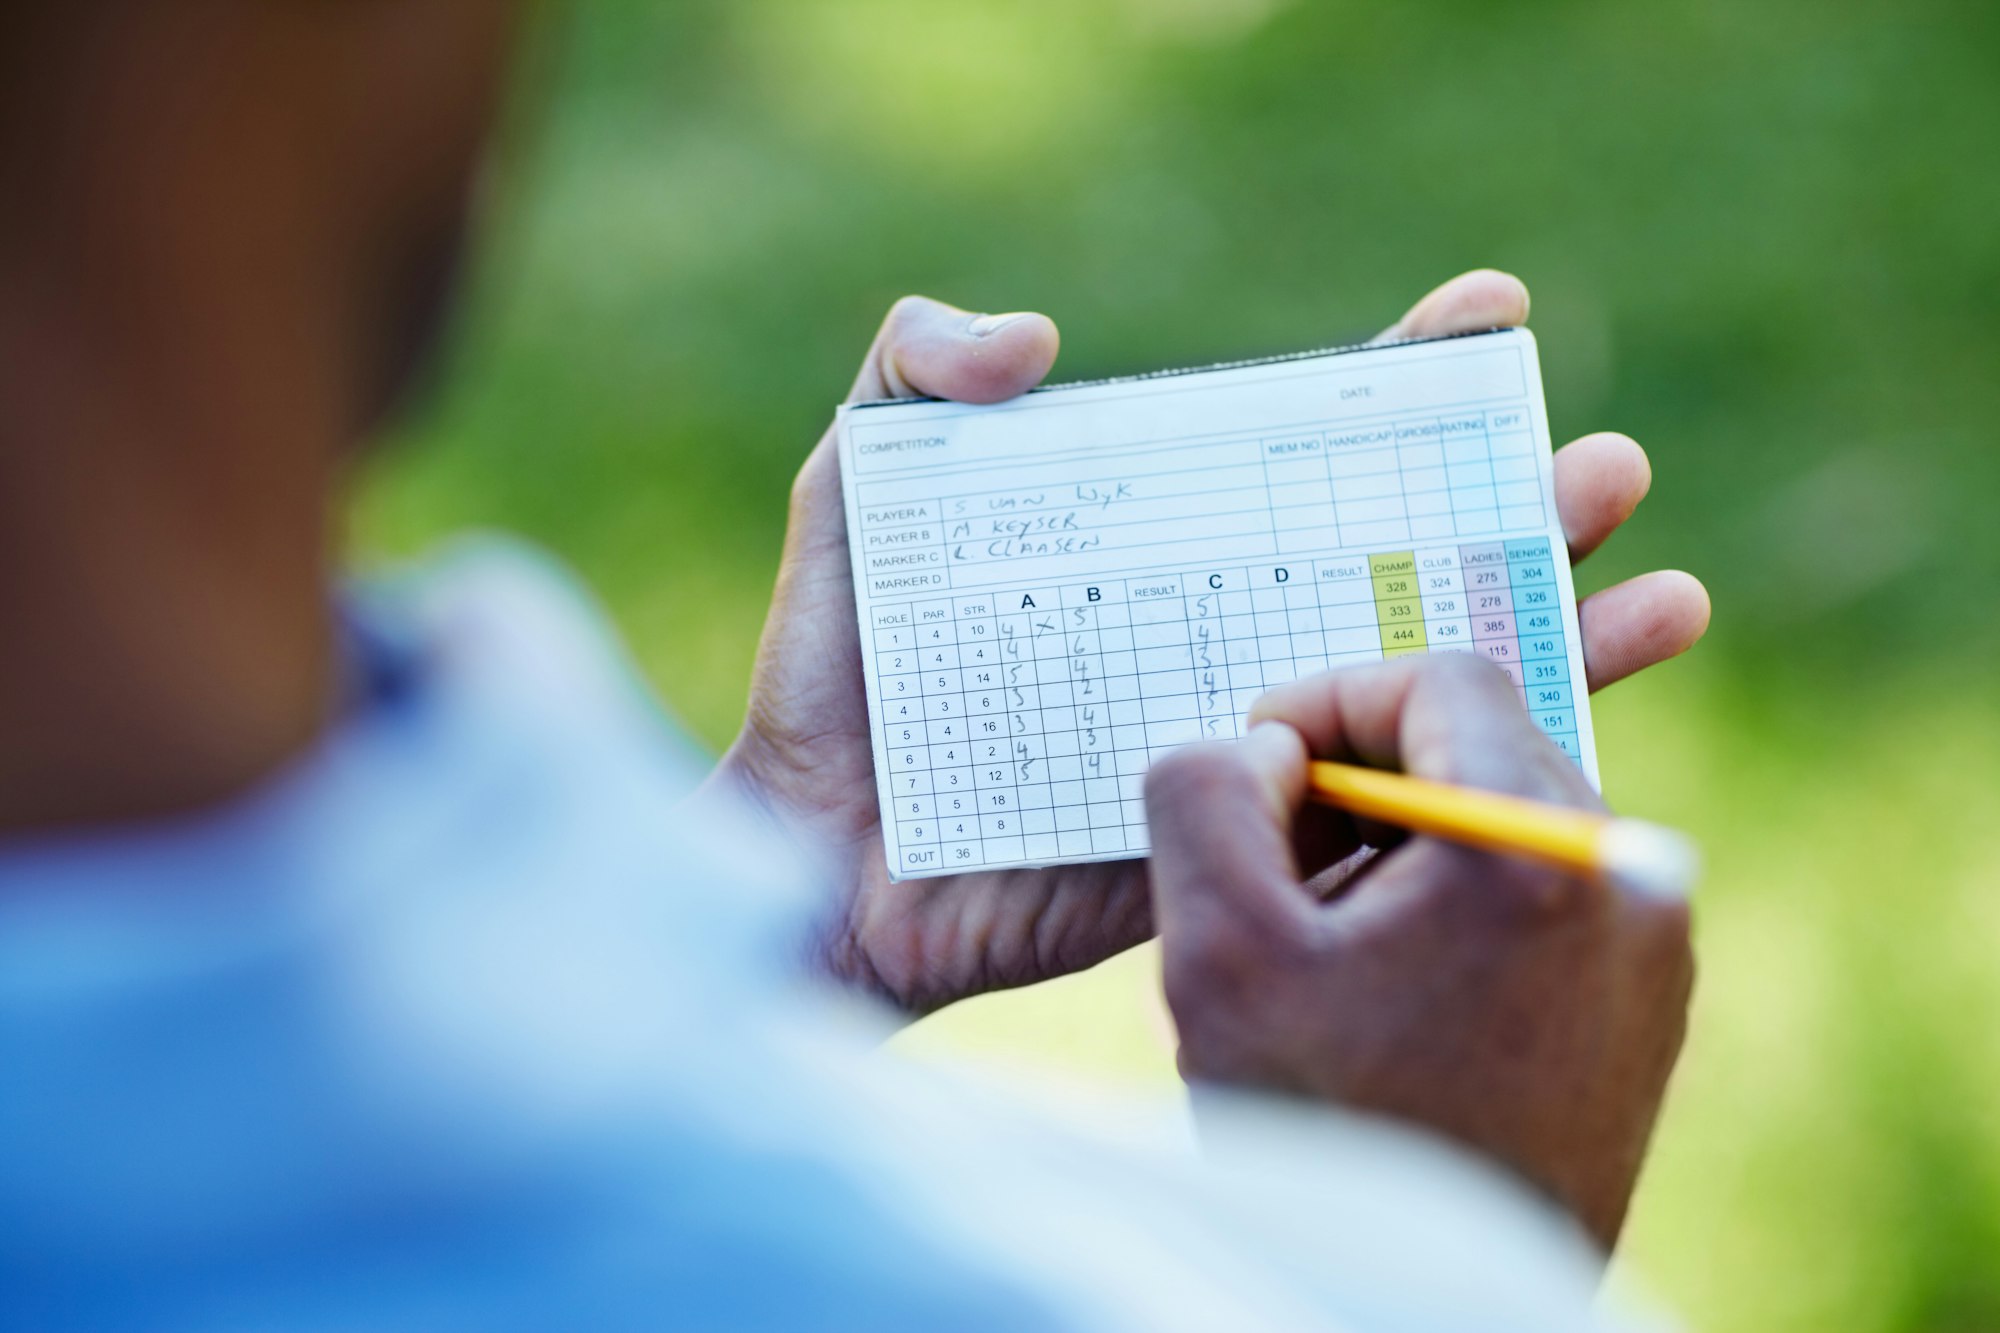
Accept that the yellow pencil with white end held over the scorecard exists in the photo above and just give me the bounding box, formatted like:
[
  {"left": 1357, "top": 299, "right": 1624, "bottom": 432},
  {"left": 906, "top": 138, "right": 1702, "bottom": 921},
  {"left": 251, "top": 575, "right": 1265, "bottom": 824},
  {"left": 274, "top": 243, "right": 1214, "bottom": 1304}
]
[{"left": 1312, "top": 763, "right": 1700, "bottom": 899}]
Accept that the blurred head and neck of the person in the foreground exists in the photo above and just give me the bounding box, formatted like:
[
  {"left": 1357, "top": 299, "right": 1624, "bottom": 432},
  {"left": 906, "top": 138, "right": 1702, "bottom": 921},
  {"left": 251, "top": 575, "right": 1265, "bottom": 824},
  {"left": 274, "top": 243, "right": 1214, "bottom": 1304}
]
[{"left": 0, "top": 0, "right": 532, "bottom": 827}]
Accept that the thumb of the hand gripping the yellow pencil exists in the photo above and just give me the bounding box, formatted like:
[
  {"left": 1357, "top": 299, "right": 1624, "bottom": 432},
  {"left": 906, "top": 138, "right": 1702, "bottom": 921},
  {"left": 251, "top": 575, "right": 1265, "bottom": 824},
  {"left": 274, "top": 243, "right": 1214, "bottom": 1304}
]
[{"left": 1146, "top": 723, "right": 1314, "bottom": 969}]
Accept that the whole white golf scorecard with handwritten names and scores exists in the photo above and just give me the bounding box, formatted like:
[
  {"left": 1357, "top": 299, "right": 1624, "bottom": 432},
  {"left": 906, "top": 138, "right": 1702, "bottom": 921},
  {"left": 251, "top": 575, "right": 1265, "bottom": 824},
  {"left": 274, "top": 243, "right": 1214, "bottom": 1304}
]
[{"left": 840, "top": 330, "right": 1598, "bottom": 879}]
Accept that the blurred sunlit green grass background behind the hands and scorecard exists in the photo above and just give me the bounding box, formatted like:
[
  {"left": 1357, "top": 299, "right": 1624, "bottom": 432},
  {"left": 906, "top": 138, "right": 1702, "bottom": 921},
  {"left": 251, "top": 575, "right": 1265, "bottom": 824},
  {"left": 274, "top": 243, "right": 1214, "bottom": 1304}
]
[{"left": 356, "top": 0, "right": 2000, "bottom": 1333}]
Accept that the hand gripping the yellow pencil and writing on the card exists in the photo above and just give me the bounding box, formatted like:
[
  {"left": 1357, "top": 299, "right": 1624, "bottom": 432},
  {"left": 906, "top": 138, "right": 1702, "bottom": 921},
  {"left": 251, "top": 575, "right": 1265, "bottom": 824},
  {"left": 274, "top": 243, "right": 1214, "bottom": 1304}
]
[{"left": 1146, "top": 656, "right": 1694, "bottom": 1249}]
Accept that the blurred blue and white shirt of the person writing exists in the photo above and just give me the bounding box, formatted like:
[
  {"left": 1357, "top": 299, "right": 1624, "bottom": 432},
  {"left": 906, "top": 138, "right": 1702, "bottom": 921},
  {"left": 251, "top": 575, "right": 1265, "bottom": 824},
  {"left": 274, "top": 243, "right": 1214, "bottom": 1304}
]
[{"left": 0, "top": 542, "right": 1648, "bottom": 1333}]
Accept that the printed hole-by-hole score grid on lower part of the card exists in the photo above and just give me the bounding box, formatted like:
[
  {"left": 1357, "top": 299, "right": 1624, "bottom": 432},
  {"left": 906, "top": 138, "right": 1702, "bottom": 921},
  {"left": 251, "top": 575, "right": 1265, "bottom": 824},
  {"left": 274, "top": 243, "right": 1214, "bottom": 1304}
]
[{"left": 874, "top": 538, "right": 1580, "bottom": 871}]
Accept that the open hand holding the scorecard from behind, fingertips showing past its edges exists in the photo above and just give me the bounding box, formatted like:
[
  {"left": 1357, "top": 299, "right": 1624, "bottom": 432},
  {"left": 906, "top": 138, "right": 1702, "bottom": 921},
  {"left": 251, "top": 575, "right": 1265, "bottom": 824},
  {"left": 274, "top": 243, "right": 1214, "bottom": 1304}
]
[{"left": 718, "top": 272, "right": 1708, "bottom": 1013}]
